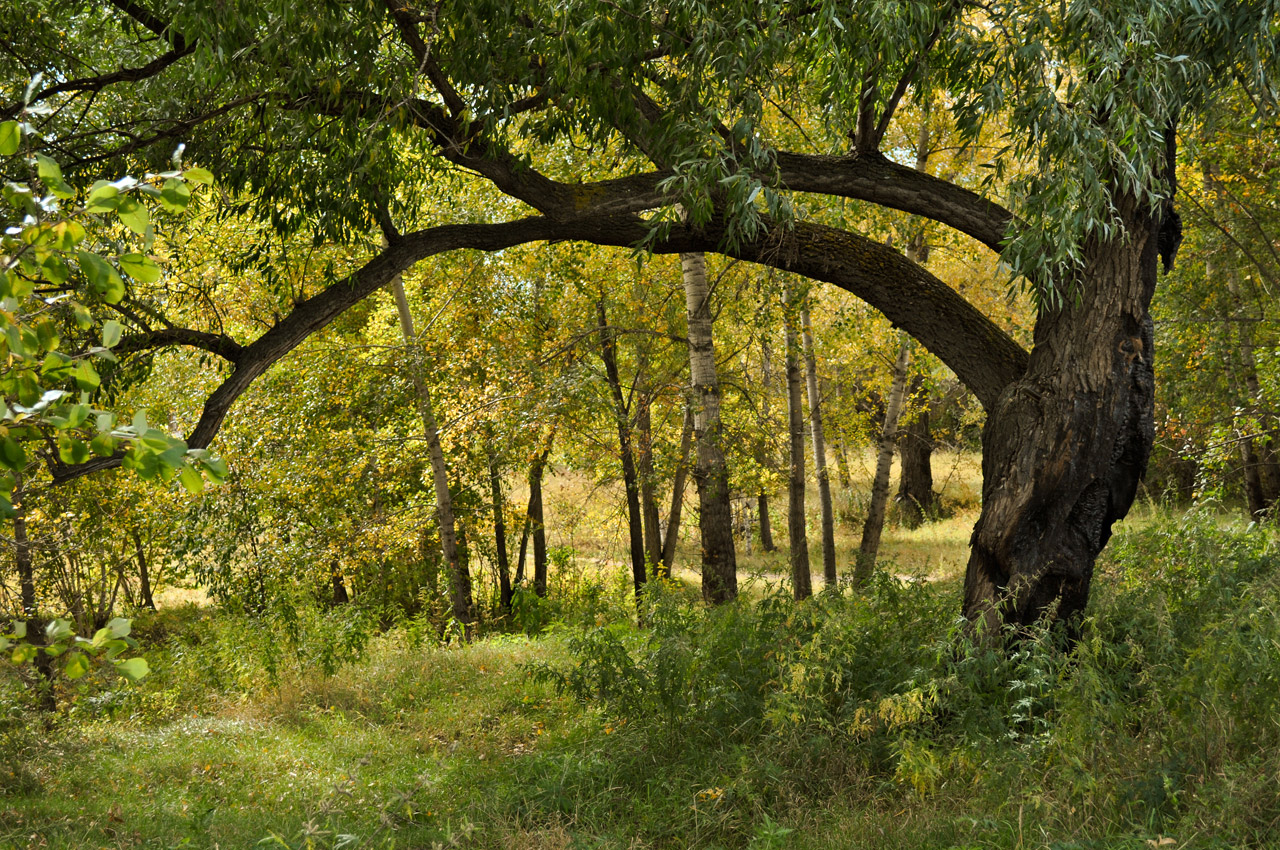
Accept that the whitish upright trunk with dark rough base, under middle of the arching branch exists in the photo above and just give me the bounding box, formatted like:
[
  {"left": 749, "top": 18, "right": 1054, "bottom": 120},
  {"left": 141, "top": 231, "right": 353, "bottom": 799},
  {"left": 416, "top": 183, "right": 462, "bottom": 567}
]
[{"left": 680, "top": 253, "right": 737, "bottom": 603}]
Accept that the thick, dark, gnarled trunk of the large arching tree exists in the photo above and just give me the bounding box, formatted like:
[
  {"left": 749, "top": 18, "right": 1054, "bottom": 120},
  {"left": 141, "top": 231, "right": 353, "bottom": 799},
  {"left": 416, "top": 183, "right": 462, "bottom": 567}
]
[{"left": 964, "top": 183, "right": 1180, "bottom": 635}]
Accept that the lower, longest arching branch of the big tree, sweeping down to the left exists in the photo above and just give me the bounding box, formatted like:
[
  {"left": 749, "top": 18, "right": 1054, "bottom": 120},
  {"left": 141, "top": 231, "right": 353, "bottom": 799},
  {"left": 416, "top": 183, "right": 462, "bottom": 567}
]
[{"left": 54, "top": 207, "right": 1027, "bottom": 483}]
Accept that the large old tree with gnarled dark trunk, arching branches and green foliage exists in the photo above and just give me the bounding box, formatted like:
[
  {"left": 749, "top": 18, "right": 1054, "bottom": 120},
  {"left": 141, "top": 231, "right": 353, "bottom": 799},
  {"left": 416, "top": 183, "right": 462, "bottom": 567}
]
[{"left": 0, "top": 0, "right": 1276, "bottom": 626}]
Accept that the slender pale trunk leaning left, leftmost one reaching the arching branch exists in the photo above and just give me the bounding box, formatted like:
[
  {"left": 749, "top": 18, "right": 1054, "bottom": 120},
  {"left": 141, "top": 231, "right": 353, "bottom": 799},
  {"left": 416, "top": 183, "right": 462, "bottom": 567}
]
[{"left": 389, "top": 275, "right": 475, "bottom": 630}]
